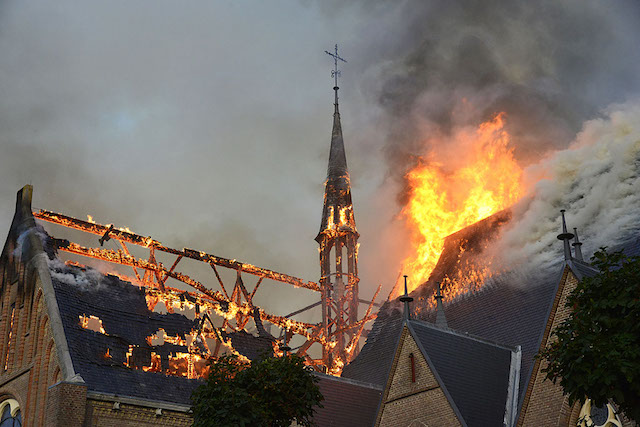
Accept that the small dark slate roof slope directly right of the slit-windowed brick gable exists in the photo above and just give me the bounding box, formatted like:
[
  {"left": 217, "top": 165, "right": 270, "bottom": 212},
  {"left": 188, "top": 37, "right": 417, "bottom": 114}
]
[{"left": 408, "top": 321, "right": 518, "bottom": 427}]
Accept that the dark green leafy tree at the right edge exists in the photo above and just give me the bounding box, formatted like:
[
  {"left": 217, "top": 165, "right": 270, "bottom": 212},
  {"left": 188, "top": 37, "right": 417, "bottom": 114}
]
[{"left": 538, "top": 248, "right": 640, "bottom": 421}]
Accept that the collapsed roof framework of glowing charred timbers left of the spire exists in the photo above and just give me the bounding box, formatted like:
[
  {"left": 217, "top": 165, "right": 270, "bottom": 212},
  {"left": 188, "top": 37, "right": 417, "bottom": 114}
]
[{"left": 33, "top": 201, "right": 376, "bottom": 374}]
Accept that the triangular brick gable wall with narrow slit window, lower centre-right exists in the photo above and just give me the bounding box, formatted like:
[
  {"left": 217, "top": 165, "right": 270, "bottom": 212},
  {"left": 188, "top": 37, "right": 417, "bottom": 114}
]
[{"left": 376, "top": 326, "right": 461, "bottom": 427}]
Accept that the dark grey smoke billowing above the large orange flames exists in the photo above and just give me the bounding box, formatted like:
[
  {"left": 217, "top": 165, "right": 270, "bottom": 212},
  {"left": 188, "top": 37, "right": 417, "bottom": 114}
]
[{"left": 358, "top": 0, "right": 640, "bottom": 186}]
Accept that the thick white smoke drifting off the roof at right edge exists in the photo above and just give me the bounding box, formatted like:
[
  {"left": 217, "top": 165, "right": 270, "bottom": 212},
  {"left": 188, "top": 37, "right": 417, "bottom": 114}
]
[{"left": 497, "top": 101, "right": 640, "bottom": 268}]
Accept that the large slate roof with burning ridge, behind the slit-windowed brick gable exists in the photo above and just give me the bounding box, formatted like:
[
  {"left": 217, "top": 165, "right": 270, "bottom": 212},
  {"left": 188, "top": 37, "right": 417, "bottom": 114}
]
[{"left": 343, "top": 211, "right": 640, "bottom": 422}]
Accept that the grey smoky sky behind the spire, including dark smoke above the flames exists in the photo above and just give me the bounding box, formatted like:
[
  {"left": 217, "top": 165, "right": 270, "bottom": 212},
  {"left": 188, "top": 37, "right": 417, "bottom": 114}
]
[{"left": 0, "top": 0, "right": 640, "bottom": 320}]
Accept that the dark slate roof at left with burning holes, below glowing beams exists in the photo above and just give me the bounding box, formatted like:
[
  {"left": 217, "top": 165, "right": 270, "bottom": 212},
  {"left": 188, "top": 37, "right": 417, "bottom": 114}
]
[{"left": 44, "top": 244, "right": 271, "bottom": 405}]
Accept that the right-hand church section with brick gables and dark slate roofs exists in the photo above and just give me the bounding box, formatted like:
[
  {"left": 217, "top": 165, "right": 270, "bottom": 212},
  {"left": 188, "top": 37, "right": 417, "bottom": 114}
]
[{"left": 343, "top": 213, "right": 640, "bottom": 427}]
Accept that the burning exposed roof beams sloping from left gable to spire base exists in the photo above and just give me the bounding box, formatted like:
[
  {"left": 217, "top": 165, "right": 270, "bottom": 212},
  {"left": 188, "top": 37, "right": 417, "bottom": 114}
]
[{"left": 34, "top": 210, "right": 377, "bottom": 374}]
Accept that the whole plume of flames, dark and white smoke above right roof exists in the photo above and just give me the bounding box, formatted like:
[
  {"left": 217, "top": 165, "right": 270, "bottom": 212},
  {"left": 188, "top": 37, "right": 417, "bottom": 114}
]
[{"left": 358, "top": 1, "right": 640, "bottom": 296}]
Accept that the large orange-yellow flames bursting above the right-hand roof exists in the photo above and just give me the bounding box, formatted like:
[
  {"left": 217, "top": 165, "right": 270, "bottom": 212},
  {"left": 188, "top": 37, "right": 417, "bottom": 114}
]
[{"left": 392, "top": 113, "right": 522, "bottom": 296}]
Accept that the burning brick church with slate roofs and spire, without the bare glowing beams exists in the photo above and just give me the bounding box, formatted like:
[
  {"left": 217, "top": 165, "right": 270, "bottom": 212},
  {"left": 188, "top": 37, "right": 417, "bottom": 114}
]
[{"left": 0, "top": 77, "right": 640, "bottom": 427}]
